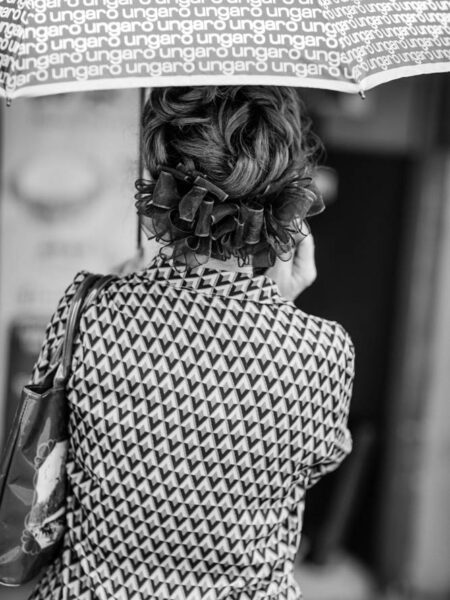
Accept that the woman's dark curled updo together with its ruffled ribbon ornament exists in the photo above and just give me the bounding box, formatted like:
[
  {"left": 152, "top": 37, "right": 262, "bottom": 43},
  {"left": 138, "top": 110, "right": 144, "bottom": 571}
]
[{"left": 136, "top": 86, "right": 323, "bottom": 268}]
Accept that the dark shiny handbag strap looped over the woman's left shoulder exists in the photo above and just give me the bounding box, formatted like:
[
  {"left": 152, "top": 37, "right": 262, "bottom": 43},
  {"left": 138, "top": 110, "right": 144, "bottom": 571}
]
[{"left": 55, "top": 273, "right": 113, "bottom": 385}]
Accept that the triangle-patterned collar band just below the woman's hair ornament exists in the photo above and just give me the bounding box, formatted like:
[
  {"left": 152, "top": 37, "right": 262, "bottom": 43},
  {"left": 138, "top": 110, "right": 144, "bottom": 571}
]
[{"left": 144, "top": 256, "right": 282, "bottom": 304}]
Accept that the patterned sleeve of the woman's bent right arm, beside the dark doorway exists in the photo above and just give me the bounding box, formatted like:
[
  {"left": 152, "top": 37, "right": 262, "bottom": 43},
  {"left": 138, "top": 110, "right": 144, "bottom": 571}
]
[{"left": 307, "top": 328, "right": 355, "bottom": 488}]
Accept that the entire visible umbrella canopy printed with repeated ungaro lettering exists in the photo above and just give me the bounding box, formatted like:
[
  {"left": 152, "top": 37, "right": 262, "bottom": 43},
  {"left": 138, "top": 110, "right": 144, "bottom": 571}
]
[{"left": 0, "top": 0, "right": 450, "bottom": 98}]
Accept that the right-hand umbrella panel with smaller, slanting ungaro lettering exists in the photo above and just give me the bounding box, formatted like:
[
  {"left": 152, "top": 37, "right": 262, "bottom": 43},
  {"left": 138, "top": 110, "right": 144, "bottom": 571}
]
[{"left": 334, "top": 0, "right": 450, "bottom": 89}]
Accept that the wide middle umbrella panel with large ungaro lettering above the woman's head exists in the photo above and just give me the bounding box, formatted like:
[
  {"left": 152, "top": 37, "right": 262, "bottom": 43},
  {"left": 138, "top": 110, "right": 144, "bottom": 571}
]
[{"left": 1, "top": 0, "right": 352, "bottom": 97}]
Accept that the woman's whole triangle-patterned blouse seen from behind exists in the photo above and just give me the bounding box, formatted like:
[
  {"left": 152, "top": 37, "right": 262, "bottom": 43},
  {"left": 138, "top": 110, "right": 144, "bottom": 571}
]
[{"left": 30, "top": 257, "right": 354, "bottom": 600}]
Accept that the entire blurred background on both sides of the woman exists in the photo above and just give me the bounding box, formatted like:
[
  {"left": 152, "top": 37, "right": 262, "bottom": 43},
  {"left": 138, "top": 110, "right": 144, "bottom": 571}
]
[{"left": 0, "top": 75, "right": 450, "bottom": 600}]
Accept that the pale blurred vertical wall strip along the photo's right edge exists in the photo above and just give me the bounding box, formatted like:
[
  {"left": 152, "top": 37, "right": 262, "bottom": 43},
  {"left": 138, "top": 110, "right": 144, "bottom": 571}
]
[{"left": 408, "top": 152, "right": 450, "bottom": 598}]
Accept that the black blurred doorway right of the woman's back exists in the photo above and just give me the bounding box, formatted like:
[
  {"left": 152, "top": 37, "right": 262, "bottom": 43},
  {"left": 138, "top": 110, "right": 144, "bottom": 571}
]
[{"left": 297, "top": 151, "right": 411, "bottom": 564}]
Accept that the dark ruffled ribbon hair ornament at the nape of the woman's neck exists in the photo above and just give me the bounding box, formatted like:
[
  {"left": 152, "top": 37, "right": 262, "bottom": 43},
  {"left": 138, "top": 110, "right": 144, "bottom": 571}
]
[{"left": 135, "top": 164, "right": 325, "bottom": 268}]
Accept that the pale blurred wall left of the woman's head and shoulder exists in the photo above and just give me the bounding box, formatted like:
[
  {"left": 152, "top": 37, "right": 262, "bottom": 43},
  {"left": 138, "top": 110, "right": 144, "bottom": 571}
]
[{"left": 0, "top": 91, "right": 138, "bottom": 450}]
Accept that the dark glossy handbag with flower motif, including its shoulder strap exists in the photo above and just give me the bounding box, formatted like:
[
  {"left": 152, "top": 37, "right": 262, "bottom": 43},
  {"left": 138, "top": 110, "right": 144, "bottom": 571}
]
[{"left": 0, "top": 274, "right": 109, "bottom": 586}]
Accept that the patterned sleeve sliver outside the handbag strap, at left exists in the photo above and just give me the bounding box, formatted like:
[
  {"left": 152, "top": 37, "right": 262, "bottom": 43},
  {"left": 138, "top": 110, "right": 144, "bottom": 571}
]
[{"left": 29, "top": 271, "right": 88, "bottom": 384}]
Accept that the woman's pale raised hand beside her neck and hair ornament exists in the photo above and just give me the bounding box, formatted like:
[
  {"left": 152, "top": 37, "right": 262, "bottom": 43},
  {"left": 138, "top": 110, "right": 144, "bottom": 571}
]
[{"left": 265, "top": 233, "right": 317, "bottom": 300}]
